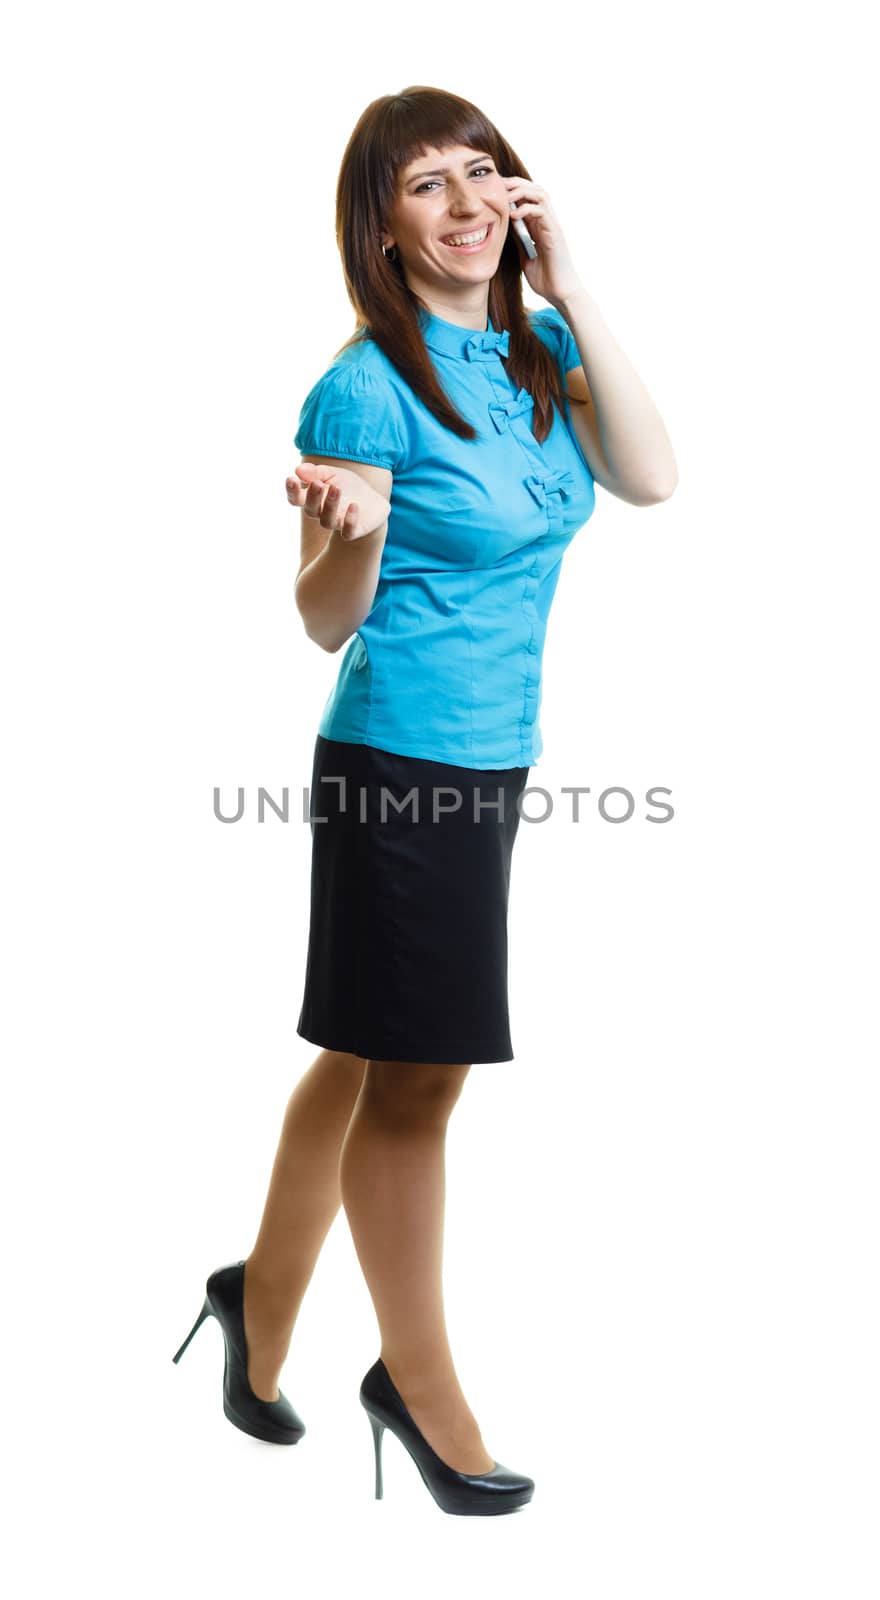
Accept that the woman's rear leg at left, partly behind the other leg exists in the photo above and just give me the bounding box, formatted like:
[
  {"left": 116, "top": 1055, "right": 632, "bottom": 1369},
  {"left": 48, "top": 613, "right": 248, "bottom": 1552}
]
[{"left": 245, "top": 1050, "right": 366, "bottom": 1400}]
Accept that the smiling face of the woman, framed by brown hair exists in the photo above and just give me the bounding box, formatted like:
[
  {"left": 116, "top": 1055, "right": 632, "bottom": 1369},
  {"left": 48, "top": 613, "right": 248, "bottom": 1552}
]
[{"left": 382, "top": 144, "right": 510, "bottom": 294}]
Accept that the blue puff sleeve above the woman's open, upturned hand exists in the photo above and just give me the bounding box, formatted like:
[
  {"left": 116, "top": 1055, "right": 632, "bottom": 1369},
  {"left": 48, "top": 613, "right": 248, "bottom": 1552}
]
[{"left": 293, "top": 362, "right": 406, "bottom": 472}]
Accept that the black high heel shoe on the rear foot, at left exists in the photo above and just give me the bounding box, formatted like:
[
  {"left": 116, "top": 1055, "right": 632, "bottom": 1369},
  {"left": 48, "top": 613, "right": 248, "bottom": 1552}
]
[{"left": 173, "top": 1261, "right": 306, "bottom": 1445}]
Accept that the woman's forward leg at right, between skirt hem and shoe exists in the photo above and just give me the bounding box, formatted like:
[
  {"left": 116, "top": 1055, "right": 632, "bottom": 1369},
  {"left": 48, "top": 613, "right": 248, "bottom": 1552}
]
[{"left": 339, "top": 1061, "right": 494, "bottom": 1472}]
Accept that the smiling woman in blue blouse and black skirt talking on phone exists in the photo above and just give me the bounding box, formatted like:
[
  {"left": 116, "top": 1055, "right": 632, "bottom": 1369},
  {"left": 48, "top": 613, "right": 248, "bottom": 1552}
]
[{"left": 174, "top": 86, "right": 675, "bottom": 1515}]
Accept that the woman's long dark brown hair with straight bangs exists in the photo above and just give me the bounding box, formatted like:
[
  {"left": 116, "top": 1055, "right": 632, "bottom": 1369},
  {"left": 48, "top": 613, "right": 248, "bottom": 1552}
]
[{"left": 336, "top": 83, "right": 586, "bottom": 443}]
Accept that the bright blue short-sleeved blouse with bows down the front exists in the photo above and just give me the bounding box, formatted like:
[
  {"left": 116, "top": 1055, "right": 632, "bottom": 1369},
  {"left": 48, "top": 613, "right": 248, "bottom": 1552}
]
[{"left": 294, "top": 306, "right": 595, "bottom": 771}]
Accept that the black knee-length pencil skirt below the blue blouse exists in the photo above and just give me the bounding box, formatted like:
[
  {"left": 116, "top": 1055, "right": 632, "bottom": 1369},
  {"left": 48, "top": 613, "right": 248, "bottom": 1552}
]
[{"left": 296, "top": 734, "right": 530, "bottom": 1064}]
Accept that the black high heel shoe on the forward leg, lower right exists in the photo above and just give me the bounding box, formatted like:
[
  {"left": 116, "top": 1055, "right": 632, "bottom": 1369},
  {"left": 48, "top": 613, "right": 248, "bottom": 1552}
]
[{"left": 360, "top": 1357, "right": 534, "bottom": 1517}]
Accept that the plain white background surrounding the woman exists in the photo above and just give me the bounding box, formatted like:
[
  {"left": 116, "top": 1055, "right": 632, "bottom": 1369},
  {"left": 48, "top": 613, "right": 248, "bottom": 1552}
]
[{"left": 0, "top": 0, "right": 880, "bottom": 1600}]
